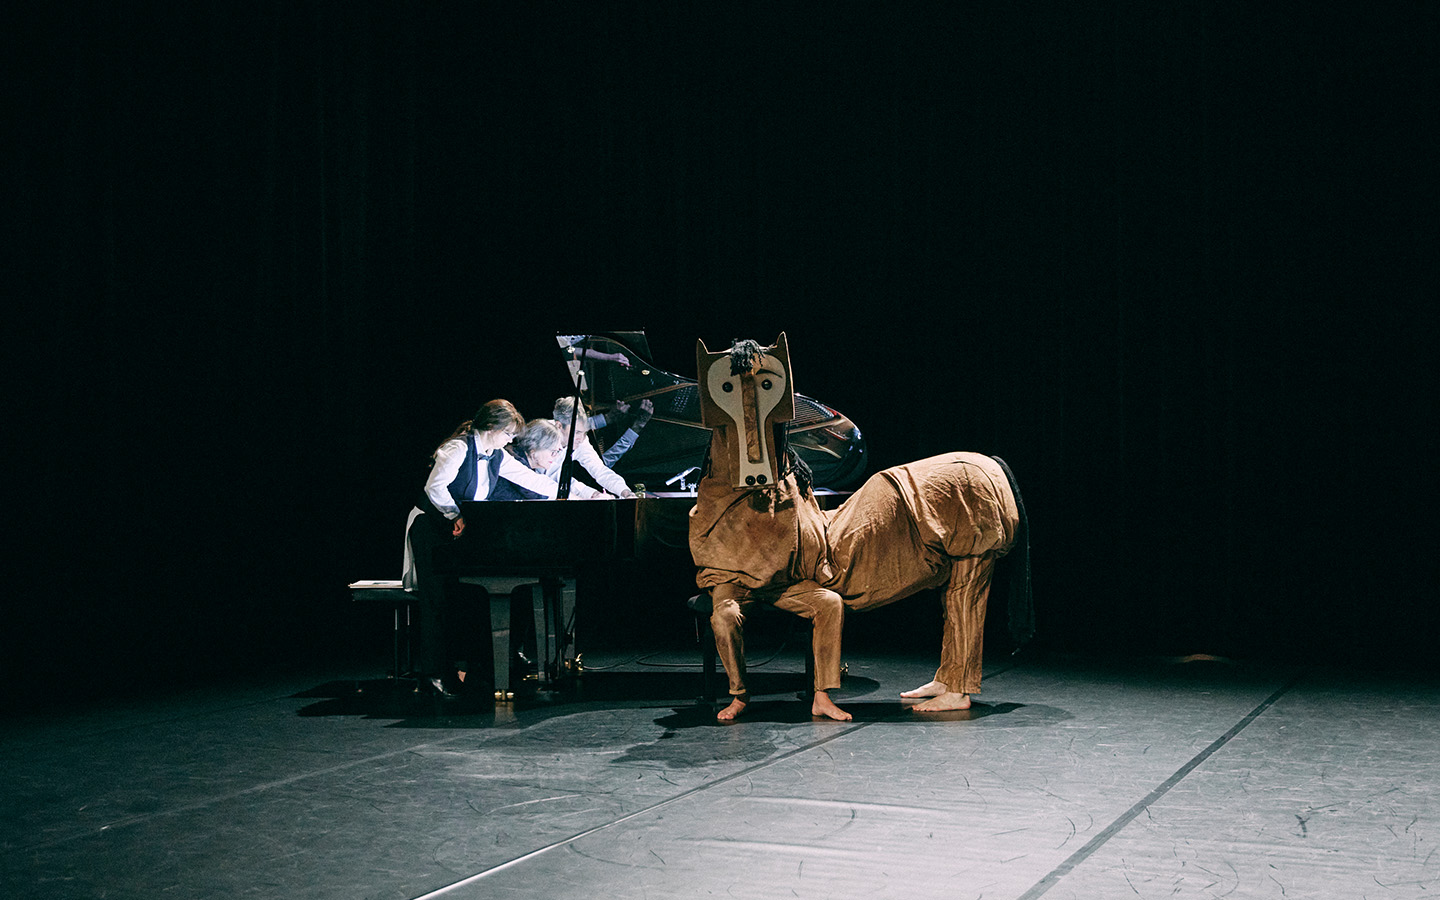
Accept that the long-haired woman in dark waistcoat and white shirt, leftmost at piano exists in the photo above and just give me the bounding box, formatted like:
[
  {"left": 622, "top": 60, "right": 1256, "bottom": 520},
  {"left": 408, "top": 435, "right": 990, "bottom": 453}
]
[{"left": 405, "top": 400, "right": 556, "bottom": 697}]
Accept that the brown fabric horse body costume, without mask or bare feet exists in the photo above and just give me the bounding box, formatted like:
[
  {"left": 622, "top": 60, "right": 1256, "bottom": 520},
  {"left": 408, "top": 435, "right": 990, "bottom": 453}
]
[{"left": 690, "top": 428, "right": 1020, "bottom": 696}]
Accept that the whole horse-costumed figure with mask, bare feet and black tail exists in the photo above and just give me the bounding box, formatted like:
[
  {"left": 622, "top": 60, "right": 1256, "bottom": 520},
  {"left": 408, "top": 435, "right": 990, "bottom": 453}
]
[{"left": 690, "top": 334, "right": 1031, "bottom": 721}]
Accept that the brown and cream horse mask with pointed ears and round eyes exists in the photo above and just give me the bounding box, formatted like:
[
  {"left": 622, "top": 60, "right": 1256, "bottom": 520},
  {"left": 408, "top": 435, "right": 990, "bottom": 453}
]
[{"left": 696, "top": 331, "right": 795, "bottom": 488}]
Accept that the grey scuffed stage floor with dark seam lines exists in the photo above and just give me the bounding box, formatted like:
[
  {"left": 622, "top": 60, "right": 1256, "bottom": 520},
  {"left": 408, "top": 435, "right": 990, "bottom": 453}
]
[{"left": 0, "top": 642, "right": 1440, "bottom": 900}]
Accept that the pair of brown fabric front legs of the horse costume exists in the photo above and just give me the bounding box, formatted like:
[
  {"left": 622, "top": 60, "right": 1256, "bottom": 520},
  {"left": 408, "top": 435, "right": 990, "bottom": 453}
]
[{"left": 710, "top": 582, "right": 845, "bottom": 697}]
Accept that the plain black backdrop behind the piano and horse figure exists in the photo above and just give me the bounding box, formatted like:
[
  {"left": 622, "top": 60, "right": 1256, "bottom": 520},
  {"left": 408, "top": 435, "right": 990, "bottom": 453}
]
[{"left": 3, "top": 1, "right": 1440, "bottom": 691}]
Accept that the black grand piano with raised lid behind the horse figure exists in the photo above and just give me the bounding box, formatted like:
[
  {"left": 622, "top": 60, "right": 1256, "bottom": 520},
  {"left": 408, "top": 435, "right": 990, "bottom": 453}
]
[{"left": 454, "top": 331, "right": 865, "bottom": 697}]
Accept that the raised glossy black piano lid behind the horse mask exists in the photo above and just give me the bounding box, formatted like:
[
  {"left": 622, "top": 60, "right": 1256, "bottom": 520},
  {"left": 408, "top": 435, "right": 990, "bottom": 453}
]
[{"left": 556, "top": 331, "right": 865, "bottom": 491}]
